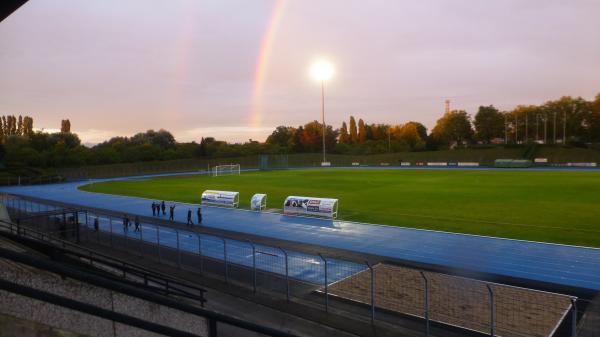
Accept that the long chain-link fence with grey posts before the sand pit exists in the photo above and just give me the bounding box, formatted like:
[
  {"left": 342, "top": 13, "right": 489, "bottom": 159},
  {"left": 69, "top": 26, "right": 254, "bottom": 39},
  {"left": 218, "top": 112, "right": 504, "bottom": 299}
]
[{"left": 2, "top": 195, "right": 577, "bottom": 337}]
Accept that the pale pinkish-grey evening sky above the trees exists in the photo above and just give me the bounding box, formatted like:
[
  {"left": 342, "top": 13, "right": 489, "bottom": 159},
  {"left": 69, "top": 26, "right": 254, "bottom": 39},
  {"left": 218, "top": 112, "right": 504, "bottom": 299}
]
[{"left": 0, "top": 0, "right": 600, "bottom": 144}]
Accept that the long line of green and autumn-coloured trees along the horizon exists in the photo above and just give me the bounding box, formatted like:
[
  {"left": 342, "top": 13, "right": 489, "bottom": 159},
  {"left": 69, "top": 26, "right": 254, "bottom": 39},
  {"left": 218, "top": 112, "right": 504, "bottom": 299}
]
[{"left": 0, "top": 94, "right": 600, "bottom": 167}]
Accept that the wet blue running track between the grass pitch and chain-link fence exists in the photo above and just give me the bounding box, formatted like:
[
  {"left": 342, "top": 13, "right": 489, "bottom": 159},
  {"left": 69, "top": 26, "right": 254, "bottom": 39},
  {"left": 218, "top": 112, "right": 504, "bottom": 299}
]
[{"left": 0, "top": 172, "right": 600, "bottom": 291}]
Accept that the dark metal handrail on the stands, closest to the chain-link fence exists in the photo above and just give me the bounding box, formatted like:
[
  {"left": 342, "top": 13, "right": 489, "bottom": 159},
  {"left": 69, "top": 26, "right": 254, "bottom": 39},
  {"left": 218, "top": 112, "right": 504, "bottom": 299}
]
[{"left": 0, "top": 220, "right": 206, "bottom": 304}]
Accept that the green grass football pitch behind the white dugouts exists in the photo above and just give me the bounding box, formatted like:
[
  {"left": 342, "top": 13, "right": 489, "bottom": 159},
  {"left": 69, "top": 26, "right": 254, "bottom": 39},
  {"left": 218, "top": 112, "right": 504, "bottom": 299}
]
[{"left": 81, "top": 169, "right": 600, "bottom": 247}]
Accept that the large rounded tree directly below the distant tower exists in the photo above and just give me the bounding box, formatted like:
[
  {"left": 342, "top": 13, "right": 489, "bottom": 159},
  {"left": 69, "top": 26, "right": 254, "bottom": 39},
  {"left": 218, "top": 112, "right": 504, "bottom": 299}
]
[{"left": 431, "top": 110, "right": 473, "bottom": 147}]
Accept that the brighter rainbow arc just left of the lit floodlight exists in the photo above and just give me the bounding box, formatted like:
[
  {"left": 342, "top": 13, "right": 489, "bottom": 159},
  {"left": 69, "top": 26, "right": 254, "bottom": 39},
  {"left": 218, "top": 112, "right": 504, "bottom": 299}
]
[{"left": 249, "top": 0, "right": 285, "bottom": 127}]
